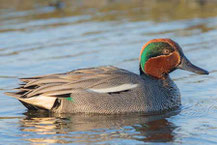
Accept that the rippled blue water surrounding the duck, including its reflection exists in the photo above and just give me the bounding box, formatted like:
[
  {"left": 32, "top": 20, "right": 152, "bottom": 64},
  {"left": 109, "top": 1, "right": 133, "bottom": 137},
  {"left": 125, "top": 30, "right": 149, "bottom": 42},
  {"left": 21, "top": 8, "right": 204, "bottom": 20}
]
[{"left": 0, "top": 0, "right": 217, "bottom": 145}]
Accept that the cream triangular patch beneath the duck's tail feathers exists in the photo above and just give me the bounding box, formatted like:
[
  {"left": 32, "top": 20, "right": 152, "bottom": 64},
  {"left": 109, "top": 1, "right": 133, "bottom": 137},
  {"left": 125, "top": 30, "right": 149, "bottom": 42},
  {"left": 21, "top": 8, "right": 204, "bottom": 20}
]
[{"left": 18, "top": 95, "right": 56, "bottom": 110}]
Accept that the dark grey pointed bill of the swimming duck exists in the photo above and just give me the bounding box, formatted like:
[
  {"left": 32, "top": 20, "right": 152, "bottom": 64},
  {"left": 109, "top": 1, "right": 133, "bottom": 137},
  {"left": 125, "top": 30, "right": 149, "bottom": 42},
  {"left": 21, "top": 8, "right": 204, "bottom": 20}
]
[{"left": 178, "top": 56, "right": 209, "bottom": 75}]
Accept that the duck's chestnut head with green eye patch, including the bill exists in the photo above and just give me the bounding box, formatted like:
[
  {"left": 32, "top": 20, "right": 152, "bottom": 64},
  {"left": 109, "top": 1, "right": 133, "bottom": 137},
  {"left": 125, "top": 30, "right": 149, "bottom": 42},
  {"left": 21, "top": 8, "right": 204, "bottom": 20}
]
[{"left": 140, "top": 39, "right": 209, "bottom": 79}]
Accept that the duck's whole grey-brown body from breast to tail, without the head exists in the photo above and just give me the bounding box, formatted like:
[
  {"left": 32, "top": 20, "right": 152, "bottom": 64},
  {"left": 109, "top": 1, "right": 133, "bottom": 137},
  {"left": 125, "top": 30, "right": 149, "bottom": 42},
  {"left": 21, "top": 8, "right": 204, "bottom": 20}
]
[{"left": 5, "top": 66, "right": 180, "bottom": 114}]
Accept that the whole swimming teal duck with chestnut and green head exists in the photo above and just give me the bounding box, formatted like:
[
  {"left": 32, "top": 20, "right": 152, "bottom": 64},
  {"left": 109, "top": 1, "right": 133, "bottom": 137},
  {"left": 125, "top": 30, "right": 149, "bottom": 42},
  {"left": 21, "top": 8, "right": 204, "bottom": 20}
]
[{"left": 6, "top": 39, "right": 209, "bottom": 114}]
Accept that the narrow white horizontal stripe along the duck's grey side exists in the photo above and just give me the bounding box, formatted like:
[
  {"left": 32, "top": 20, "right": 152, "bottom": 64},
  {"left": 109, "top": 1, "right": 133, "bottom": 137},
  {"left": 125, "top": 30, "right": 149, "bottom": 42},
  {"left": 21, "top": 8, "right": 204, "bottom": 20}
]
[{"left": 88, "top": 84, "right": 138, "bottom": 93}]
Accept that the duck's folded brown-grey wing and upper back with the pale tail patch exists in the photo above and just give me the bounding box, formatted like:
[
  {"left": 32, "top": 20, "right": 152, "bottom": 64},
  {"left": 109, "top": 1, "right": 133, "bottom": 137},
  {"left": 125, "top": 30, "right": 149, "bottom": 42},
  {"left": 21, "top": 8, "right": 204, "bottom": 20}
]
[{"left": 6, "top": 66, "right": 142, "bottom": 110}]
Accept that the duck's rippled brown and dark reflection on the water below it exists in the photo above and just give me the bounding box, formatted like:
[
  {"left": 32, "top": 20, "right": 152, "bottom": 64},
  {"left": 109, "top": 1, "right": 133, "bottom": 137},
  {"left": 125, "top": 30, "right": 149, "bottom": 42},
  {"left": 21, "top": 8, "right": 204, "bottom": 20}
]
[{"left": 20, "top": 111, "right": 178, "bottom": 143}]
